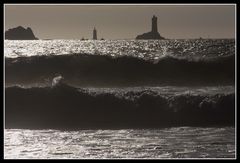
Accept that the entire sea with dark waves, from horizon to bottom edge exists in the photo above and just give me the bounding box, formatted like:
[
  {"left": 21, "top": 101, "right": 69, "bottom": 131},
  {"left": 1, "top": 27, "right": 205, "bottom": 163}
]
[{"left": 4, "top": 39, "right": 236, "bottom": 159}]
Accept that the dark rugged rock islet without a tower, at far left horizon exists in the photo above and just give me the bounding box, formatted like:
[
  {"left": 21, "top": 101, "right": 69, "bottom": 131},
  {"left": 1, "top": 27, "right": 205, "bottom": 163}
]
[{"left": 5, "top": 26, "right": 38, "bottom": 40}]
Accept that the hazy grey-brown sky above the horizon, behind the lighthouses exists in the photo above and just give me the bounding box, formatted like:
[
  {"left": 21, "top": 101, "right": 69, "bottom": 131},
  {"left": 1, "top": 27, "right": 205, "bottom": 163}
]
[{"left": 5, "top": 5, "right": 235, "bottom": 39}]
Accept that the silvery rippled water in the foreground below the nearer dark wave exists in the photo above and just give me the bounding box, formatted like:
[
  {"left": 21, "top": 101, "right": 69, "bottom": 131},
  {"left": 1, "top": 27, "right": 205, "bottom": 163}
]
[{"left": 4, "top": 127, "right": 236, "bottom": 158}]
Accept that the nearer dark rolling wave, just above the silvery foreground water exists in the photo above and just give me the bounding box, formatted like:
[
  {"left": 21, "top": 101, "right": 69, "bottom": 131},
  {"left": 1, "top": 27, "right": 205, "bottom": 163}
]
[{"left": 5, "top": 84, "right": 235, "bottom": 130}]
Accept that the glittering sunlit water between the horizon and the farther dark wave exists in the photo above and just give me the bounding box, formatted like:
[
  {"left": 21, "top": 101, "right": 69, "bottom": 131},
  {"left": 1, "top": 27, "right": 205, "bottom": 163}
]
[{"left": 4, "top": 39, "right": 235, "bottom": 60}]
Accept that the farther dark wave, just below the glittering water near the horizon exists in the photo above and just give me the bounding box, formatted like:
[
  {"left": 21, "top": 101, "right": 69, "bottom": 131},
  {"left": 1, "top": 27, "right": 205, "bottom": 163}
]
[{"left": 5, "top": 54, "right": 235, "bottom": 87}]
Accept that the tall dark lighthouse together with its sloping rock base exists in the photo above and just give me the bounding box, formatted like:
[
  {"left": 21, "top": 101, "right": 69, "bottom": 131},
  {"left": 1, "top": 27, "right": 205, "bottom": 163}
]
[{"left": 136, "top": 15, "right": 165, "bottom": 40}]
